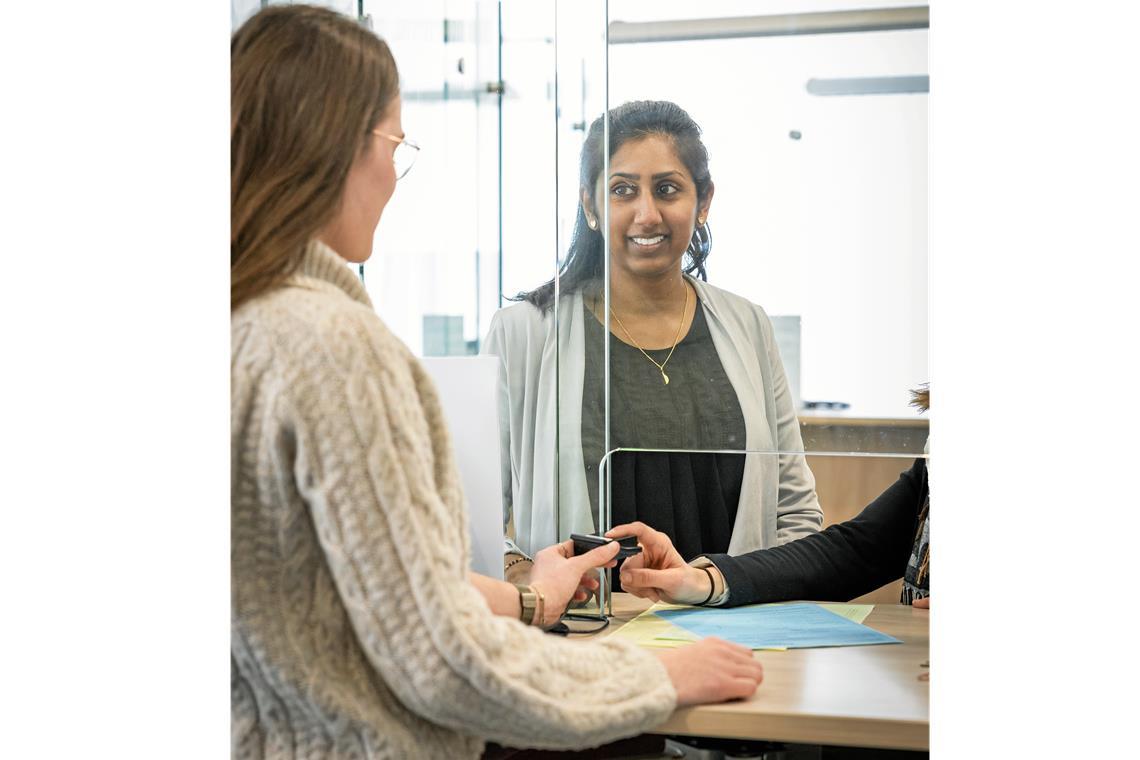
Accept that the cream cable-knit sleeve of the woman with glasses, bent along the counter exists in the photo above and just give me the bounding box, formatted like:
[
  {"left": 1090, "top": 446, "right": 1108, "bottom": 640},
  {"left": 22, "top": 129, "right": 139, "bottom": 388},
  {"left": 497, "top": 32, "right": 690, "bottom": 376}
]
[{"left": 272, "top": 309, "right": 676, "bottom": 749}]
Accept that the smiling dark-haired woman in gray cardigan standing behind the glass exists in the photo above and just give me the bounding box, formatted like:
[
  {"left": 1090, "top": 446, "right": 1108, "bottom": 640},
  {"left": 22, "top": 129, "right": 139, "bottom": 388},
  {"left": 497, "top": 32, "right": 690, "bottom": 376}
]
[{"left": 485, "top": 100, "right": 822, "bottom": 577}]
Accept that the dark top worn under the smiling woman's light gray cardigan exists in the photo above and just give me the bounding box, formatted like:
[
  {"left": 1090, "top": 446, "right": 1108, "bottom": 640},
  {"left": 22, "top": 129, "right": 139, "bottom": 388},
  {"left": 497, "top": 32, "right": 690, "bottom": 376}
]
[{"left": 581, "top": 303, "right": 746, "bottom": 559}]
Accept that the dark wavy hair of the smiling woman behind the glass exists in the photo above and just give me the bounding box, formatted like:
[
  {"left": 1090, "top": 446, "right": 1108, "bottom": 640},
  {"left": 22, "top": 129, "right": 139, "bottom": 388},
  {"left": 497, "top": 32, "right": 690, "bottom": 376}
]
[{"left": 513, "top": 100, "right": 713, "bottom": 311}]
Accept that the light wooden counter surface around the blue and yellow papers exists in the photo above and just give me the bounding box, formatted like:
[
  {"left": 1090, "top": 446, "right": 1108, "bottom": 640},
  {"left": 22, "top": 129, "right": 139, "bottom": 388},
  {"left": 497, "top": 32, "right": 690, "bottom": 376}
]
[{"left": 592, "top": 594, "right": 930, "bottom": 750}]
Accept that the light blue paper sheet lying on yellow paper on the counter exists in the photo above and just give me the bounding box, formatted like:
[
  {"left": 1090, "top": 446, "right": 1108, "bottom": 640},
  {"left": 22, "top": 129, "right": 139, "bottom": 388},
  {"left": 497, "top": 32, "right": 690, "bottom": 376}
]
[{"left": 657, "top": 604, "right": 902, "bottom": 649}]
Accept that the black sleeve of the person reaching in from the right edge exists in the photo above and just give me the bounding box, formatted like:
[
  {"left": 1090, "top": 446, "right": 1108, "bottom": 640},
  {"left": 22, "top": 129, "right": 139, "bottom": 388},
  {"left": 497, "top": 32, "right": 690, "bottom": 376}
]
[{"left": 706, "top": 459, "right": 928, "bottom": 607}]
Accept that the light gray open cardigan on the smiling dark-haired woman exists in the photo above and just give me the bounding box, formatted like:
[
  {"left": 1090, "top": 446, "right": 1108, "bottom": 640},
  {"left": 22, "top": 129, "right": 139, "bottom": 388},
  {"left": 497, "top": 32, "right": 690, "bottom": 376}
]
[{"left": 483, "top": 278, "right": 823, "bottom": 555}]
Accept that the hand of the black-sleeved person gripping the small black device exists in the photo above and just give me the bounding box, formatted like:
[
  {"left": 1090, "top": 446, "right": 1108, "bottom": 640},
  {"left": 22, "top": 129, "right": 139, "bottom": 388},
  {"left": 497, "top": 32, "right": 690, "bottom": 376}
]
[{"left": 605, "top": 522, "right": 711, "bottom": 604}]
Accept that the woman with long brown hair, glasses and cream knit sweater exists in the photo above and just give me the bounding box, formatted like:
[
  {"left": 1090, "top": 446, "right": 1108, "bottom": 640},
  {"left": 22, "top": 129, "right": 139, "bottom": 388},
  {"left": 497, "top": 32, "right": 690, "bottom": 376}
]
[{"left": 230, "top": 6, "right": 762, "bottom": 758}]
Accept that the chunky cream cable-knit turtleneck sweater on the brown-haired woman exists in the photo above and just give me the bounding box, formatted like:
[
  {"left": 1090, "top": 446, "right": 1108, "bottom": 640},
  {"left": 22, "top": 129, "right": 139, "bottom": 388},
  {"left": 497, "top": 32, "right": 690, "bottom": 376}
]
[{"left": 230, "top": 244, "right": 676, "bottom": 759}]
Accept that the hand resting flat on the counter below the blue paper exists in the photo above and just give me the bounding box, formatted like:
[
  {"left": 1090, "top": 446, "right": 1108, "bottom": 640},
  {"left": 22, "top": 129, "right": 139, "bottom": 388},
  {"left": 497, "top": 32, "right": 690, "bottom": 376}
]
[{"left": 657, "top": 637, "right": 764, "bottom": 708}]
